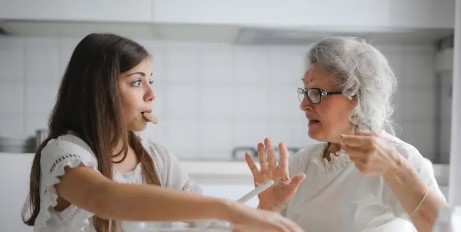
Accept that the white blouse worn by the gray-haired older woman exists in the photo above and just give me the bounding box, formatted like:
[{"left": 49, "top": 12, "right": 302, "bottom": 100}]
[{"left": 282, "top": 133, "right": 445, "bottom": 232}]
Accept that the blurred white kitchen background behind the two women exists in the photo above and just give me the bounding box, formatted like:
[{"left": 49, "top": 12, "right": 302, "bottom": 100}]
[{"left": 0, "top": 0, "right": 461, "bottom": 232}]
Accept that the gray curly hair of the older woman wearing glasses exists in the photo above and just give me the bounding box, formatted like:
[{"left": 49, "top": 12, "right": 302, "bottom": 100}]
[{"left": 307, "top": 37, "right": 397, "bottom": 133}]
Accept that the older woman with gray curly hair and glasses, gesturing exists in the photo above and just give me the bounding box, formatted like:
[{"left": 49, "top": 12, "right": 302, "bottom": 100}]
[{"left": 246, "top": 37, "right": 444, "bottom": 232}]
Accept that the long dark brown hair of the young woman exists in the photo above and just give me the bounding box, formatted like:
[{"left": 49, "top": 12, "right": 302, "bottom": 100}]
[{"left": 21, "top": 34, "right": 160, "bottom": 232}]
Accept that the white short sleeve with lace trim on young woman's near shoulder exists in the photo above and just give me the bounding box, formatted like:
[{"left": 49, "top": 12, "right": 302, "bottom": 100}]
[{"left": 35, "top": 135, "right": 99, "bottom": 227}]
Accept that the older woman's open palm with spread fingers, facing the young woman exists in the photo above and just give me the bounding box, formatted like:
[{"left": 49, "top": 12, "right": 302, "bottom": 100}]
[{"left": 245, "top": 138, "right": 306, "bottom": 211}]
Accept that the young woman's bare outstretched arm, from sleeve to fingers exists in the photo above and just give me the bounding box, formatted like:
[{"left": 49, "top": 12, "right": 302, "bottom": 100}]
[{"left": 56, "top": 166, "right": 302, "bottom": 231}]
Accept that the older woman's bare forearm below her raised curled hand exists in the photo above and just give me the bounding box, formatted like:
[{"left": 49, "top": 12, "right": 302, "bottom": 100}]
[{"left": 383, "top": 154, "right": 446, "bottom": 232}]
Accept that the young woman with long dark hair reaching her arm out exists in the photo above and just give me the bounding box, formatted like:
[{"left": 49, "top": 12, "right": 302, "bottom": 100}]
[{"left": 22, "top": 34, "right": 300, "bottom": 232}]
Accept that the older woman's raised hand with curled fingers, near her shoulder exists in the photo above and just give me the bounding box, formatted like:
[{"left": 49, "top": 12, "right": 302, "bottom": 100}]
[{"left": 341, "top": 131, "right": 400, "bottom": 175}]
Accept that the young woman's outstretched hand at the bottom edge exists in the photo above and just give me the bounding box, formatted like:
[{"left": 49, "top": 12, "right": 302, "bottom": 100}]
[{"left": 226, "top": 202, "right": 304, "bottom": 232}]
